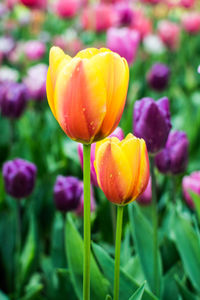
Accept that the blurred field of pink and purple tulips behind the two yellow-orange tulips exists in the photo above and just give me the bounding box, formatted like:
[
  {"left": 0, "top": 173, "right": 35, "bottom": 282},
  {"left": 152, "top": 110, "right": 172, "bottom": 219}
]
[{"left": 0, "top": 0, "right": 200, "bottom": 300}]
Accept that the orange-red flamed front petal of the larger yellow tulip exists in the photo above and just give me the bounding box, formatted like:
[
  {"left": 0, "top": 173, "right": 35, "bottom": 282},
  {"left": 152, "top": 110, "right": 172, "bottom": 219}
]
[{"left": 54, "top": 57, "right": 106, "bottom": 143}]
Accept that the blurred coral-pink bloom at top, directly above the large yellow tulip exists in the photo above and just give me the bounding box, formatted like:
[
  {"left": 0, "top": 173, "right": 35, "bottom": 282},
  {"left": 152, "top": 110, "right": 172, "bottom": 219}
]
[{"left": 81, "top": 4, "right": 117, "bottom": 32}]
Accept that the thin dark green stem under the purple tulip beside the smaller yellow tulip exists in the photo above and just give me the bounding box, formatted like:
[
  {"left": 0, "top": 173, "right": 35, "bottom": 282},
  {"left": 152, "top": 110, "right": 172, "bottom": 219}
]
[{"left": 150, "top": 156, "right": 159, "bottom": 295}]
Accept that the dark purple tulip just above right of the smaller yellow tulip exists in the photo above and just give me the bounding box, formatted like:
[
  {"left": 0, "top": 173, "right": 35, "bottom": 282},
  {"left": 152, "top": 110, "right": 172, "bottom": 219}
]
[{"left": 133, "top": 97, "right": 171, "bottom": 154}]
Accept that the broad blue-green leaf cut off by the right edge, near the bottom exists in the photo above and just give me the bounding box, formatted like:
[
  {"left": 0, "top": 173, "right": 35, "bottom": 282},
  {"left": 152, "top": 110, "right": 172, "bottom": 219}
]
[{"left": 172, "top": 213, "right": 200, "bottom": 291}]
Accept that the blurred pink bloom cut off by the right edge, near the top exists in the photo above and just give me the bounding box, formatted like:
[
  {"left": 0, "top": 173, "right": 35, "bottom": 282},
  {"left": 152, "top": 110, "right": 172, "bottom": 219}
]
[{"left": 182, "top": 12, "right": 200, "bottom": 34}]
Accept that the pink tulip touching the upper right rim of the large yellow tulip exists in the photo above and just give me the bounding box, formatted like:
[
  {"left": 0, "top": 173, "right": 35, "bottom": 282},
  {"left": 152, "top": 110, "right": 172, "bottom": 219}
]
[{"left": 106, "top": 27, "right": 140, "bottom": 64}]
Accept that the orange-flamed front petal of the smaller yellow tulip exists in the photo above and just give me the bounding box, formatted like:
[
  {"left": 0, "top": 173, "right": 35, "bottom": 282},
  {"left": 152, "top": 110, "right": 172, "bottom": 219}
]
[{"left": 94, "top": 138, "right": 132, "bottom": 204}]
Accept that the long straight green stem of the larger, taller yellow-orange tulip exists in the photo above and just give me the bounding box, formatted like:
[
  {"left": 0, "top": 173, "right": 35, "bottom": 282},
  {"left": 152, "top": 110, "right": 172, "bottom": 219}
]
[{"left": 83, "top": 145, "right": 91, "bottom": 300}]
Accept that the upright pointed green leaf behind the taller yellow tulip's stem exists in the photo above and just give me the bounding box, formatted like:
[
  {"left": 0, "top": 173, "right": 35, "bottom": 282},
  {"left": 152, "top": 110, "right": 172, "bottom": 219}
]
[{"left": 65, "top": 216, "right": 109, "bottom": 300}]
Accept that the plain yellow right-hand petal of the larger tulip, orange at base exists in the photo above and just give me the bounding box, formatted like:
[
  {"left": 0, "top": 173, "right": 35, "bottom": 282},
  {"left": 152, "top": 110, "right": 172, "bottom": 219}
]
[{"left": 91, "top": 52, "right": 129, "bottom": 140}]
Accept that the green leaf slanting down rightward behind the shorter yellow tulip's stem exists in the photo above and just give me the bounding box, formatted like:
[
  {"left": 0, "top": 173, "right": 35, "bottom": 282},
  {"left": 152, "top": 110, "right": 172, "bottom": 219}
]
[{"left": 92, "top": 243, "right": 157, "bottom": 300}]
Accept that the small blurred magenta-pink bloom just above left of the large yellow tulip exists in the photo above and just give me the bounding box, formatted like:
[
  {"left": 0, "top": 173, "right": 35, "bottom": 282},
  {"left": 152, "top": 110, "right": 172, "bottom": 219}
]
[{"left": 24, "top": 40, "right": 46, "bottom": 60}]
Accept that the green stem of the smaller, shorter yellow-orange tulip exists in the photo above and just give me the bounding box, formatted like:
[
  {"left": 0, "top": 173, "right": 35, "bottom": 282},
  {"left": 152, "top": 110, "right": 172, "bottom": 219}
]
[{"left": 113, "top": 206, "right": 124, "bottom": 300}]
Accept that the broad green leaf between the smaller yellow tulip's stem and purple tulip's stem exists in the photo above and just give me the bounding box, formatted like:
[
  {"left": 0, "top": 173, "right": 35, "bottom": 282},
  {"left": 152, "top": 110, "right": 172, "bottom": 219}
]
[{"left": 128, "top": 203, "right": 162, "bottom": 296}]
